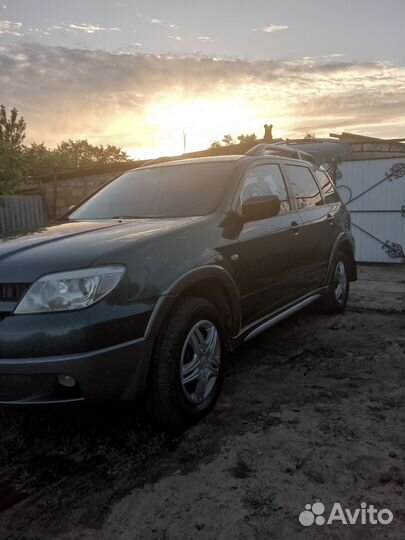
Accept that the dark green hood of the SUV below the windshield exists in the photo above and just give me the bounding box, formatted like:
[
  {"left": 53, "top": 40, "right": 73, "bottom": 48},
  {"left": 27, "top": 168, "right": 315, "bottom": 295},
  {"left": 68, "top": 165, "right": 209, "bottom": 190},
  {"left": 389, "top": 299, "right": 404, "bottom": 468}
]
[{"left": 0, "top": 217, "right": 201, "bottom": 283}]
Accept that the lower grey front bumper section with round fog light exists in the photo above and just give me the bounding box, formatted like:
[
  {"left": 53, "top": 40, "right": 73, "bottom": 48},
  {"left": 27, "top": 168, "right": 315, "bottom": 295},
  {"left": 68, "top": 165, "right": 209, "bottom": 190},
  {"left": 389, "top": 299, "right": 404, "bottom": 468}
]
[{"left": 0, "top": 338, "right": 151, "bottom": 405}]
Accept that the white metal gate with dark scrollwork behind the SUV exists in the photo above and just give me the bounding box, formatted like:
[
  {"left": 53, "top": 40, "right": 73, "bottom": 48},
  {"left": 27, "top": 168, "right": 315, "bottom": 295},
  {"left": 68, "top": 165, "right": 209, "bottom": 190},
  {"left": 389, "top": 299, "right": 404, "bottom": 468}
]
[{"left": 337, "top": 158, "right": 405, "bottom": 263}]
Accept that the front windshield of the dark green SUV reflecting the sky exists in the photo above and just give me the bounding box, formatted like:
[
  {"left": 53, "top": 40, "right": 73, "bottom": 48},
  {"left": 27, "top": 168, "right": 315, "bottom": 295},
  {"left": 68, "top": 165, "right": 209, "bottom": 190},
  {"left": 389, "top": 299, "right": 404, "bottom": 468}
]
[{"left": 68, "top": 161, "right": 235, "bottom": 220}]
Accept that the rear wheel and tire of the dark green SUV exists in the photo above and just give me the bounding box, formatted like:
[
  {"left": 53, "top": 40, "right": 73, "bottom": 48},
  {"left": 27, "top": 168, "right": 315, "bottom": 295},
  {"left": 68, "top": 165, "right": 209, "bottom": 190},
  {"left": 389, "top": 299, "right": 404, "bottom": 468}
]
[{"left": 319, "top": 251, "right": 350, "bottom": 314}]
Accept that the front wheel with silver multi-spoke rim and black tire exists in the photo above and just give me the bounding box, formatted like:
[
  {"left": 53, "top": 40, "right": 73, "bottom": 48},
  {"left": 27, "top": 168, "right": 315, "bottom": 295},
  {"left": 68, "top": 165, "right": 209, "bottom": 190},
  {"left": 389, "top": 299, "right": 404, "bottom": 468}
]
[{"left": 148, "top": 297, "right": 226, "bottom": 428}]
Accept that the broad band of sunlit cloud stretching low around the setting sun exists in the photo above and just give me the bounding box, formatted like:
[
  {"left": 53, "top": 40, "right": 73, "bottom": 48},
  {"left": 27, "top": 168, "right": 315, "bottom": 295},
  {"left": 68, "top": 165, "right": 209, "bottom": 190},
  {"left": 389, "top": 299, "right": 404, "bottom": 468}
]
[{"left": 0, "top": 43, "right": 405, "bottom": 151}]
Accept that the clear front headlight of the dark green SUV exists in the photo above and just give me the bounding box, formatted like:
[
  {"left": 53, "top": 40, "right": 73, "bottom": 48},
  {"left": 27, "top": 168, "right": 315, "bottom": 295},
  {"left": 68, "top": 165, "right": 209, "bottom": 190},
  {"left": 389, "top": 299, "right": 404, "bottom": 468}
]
[{"left": 14, "top": 265, "right": 125, "bottom": 315}]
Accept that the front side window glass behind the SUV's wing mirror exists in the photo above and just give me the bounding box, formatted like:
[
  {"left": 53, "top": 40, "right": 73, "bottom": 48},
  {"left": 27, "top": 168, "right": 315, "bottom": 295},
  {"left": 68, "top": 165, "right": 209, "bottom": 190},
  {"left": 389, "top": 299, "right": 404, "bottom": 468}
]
[{"left": 240, "top": 164, "right": 290, "bottom": 215}]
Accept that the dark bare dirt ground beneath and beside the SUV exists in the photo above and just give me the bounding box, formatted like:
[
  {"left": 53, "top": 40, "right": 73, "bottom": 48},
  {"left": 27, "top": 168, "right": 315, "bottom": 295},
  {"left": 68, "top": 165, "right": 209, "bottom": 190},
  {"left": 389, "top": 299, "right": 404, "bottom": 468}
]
[{"left": 0, "top": 265, "right": 405, "bottom": 540}]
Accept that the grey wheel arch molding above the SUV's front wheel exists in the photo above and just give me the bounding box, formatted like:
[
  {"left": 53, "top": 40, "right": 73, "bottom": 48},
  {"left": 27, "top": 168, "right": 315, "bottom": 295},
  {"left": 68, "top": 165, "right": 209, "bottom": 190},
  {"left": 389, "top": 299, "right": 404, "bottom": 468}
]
[{"left": 145, "top": 265, "right": 241, "bottom": 338}]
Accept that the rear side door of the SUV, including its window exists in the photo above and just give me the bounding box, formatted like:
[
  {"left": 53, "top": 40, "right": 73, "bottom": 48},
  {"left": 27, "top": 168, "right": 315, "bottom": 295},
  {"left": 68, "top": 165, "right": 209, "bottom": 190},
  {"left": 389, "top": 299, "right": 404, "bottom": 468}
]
[{"left": 283, "top": 163, "right": 334, "bottom": 292}]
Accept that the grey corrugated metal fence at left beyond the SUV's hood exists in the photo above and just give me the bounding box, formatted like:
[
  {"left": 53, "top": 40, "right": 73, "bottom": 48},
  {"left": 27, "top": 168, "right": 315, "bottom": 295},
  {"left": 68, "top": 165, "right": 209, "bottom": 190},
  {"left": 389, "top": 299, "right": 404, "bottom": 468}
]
[{"left": 0, "top": 195, "right": 47, "bottom": 234}]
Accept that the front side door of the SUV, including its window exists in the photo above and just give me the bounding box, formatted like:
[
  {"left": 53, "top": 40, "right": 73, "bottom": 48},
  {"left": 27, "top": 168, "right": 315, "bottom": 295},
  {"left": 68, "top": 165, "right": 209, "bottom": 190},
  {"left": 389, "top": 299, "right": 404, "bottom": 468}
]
[{"left": 236, "top": 163, "right": 302, "bottom": 326}]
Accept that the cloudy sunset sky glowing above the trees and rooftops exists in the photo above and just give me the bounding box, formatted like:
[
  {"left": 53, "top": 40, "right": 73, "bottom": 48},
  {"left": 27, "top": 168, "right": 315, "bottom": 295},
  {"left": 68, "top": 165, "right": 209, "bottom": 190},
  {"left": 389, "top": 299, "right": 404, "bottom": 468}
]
[{"left": 0, "top": 0, "right": 405, "bottom": 158}]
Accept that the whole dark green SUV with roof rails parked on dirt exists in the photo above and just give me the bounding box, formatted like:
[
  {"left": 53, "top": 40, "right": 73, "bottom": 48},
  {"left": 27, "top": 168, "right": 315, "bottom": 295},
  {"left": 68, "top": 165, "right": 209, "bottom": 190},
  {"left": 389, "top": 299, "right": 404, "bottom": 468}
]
[{"left": 0, "top": 145, "right": 356, "bottom": 425}]
